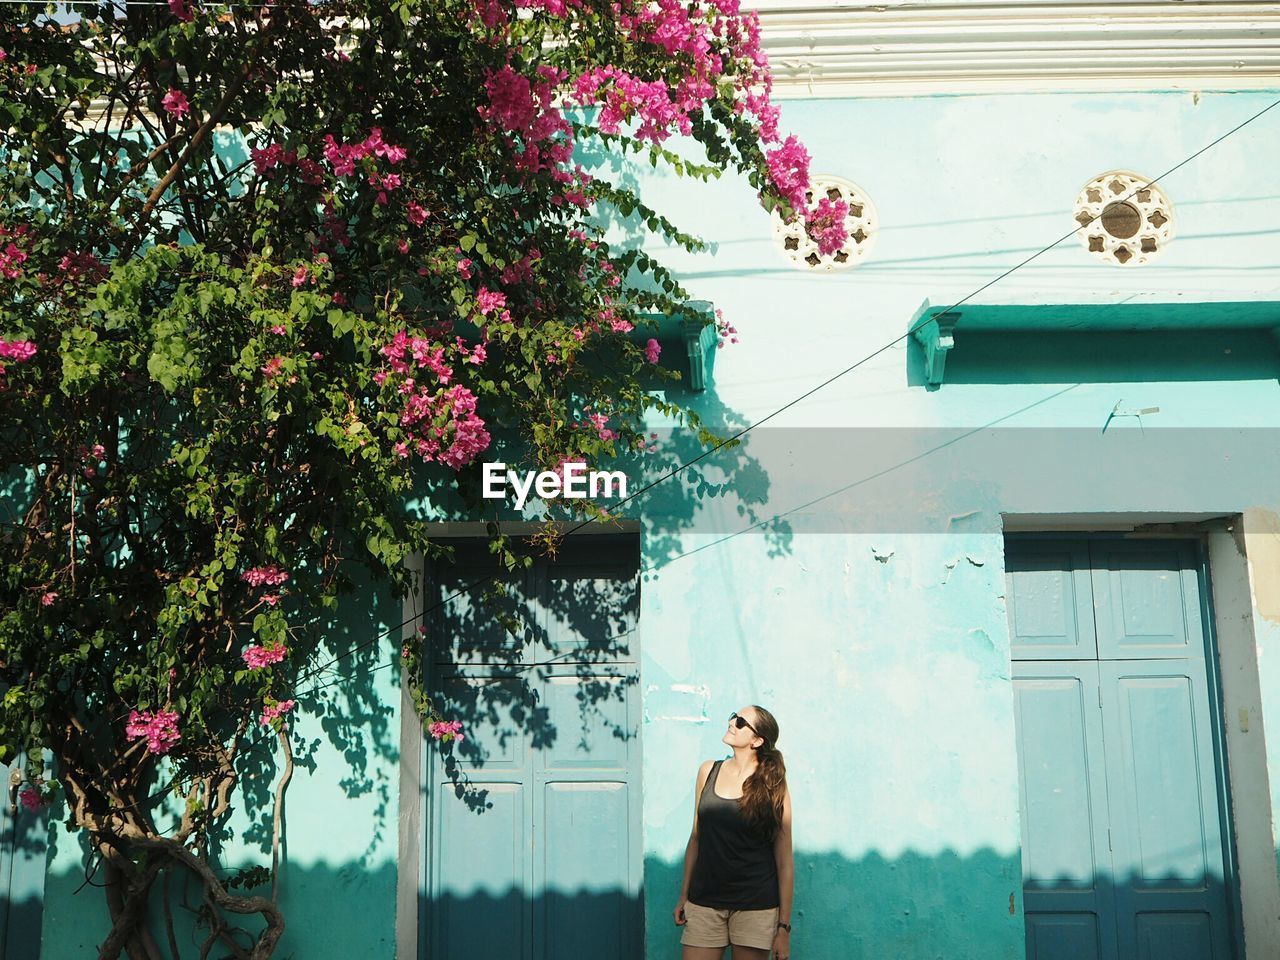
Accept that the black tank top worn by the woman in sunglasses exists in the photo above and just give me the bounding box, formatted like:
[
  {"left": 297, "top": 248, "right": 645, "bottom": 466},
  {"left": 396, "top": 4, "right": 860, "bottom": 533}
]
[{"left": 689, "top": 760, "right": 778, "bottom": 910}]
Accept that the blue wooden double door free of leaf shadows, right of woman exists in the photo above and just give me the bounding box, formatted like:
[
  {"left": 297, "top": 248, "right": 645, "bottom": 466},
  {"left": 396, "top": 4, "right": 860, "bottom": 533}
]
[{"left": 1006, "top": 540, "right": 1235, "bottom": 960}]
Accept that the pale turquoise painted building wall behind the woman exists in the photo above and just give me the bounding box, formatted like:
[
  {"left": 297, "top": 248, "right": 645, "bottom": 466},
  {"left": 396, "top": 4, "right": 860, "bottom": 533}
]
[{"left": 24, "top": 92, "right": 1280, "bottom": 960}]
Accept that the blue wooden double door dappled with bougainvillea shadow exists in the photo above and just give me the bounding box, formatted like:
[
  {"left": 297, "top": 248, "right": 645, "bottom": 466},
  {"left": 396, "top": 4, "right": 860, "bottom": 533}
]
[{"left": 424, "top": 535, "right": 643, "bottom": 960}]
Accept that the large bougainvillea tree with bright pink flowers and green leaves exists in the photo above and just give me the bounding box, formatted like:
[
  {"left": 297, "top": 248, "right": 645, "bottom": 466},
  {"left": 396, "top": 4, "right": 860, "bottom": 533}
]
[{"left": 0, "top": 0, "right": 844, "bottom": 960}]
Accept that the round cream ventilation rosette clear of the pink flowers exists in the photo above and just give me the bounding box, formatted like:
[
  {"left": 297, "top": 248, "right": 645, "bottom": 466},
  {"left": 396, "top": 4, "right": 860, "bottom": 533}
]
[{"left": 1074, "top": 170, "right": 1174, "bottom": 266}]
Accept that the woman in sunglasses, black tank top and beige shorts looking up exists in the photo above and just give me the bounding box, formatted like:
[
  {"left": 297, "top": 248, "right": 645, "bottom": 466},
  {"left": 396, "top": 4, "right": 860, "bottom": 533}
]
[{"left": 673, "top": 707, "right": 795, "bottom": 960}]
